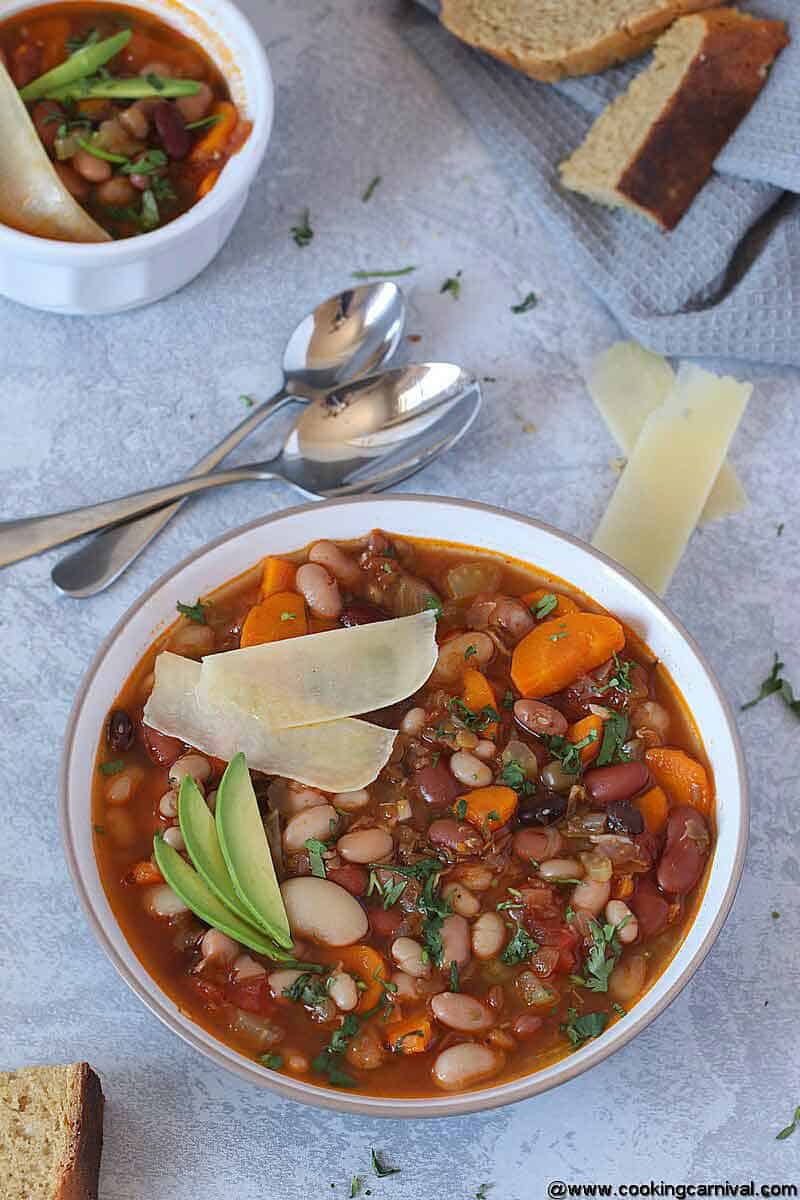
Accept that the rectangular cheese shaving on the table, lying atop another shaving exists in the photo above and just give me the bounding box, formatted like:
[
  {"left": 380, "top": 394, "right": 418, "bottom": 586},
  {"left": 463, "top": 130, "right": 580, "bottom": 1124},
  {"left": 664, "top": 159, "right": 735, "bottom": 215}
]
[{"left": 593, "top": 364, "right": 753, "bottom": 593}]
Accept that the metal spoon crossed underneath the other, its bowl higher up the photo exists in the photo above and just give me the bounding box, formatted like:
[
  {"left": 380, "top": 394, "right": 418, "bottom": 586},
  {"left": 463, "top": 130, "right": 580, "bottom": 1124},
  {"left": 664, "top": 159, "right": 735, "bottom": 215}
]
[{"left": 50, "top": 283, "right": 405, "bottom": 598}]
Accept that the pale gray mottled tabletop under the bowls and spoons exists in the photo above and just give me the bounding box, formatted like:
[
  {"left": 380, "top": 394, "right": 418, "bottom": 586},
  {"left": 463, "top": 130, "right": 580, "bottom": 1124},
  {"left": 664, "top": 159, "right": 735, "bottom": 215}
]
[{"left": 0, "top": 0, "right": 800, "bottom": 1200}]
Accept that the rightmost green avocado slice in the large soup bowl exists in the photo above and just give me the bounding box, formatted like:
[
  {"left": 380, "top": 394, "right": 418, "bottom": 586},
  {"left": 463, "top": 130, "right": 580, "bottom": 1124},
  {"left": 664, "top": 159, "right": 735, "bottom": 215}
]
[{"left": 216, "top": 754, "right": 291, "bottom": 949}]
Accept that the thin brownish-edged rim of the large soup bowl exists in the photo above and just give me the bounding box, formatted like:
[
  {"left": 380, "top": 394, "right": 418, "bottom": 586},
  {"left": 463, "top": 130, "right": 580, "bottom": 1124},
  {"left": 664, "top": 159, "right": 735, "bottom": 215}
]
[{"left": 59, "top": 492, "right": 750, "bottom": 1118}]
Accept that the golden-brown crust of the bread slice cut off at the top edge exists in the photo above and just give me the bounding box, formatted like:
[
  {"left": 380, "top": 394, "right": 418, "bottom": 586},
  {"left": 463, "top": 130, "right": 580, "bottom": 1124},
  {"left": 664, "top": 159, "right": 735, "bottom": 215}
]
[{"left": 440, "top": 0, "right": 734, "bottom": 83}]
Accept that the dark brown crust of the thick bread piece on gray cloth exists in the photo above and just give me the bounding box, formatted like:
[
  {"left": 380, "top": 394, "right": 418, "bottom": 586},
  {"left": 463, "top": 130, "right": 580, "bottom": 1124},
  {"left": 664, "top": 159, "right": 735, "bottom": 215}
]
[{"left": 618, "top": 8, "right": 789, "bottom": 229}]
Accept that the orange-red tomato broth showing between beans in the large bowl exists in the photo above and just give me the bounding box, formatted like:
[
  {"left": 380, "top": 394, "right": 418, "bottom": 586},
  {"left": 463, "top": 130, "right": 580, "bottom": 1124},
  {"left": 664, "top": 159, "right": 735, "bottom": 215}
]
[{"left": 92, "top": 535, "right": 714, "bottom": 1098}]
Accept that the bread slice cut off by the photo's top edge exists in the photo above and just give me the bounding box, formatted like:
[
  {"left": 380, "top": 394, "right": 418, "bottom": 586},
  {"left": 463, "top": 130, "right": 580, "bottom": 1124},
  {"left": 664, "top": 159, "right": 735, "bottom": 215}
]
[{"left": 441, "top": 0, "right": 722, "bottom": 83}]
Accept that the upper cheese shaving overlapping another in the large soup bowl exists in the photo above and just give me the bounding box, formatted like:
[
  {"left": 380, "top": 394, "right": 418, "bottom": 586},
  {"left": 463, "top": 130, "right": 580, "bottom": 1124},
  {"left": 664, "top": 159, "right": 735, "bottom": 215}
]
[{"left": 198, "top": 612, "right": 438, "bottom": 728}]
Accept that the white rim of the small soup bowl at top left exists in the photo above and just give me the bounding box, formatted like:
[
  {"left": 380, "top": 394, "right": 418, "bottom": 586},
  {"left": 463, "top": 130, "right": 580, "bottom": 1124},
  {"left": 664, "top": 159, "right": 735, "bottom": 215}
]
[{"left": 0, "top": 0, "right": 275, "bottom": 258}]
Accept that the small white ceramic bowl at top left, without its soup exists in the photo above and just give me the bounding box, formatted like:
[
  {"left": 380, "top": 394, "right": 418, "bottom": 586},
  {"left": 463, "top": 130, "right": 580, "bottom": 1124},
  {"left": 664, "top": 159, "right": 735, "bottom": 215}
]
[{"left": 0, "top": 0, "right": 273, "bottom": 316}]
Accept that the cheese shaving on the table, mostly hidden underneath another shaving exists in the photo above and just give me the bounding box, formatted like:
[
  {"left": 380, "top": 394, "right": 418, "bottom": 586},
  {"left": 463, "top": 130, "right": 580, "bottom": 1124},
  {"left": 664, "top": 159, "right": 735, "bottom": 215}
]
[{"left": 587, "top": 342, "right": 747, "bottom": 524}]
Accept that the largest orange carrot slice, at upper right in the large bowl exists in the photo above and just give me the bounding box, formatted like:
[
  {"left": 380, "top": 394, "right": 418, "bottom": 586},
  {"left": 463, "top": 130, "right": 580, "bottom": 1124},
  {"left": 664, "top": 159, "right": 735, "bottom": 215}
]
[{"left": 511, "top": 612, "right": 625, "bottom": 700}]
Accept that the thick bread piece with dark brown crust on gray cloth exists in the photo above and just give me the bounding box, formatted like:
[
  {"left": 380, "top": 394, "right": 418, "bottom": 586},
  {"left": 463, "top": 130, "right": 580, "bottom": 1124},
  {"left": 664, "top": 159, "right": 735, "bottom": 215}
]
[{"left": 559, "top": 8, "right": 789, "bottom": 229}]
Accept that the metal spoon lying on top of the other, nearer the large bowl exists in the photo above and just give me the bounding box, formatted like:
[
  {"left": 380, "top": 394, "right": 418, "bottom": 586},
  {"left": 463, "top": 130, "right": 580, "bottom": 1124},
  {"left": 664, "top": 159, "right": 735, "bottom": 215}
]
[{"left": 0, "top": 362, "right": 481, "bottom": 566}]
